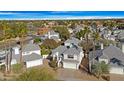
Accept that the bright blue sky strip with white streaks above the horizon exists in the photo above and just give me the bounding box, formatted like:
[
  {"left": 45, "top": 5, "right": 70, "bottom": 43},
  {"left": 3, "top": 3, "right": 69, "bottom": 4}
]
[{"left": 0, "top": 11, "right": 124, "bottom": 20}]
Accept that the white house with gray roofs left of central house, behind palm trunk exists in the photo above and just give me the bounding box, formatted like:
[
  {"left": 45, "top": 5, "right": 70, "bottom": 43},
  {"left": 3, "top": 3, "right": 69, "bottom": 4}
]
[{"left": 11, "top": 43, "right": 43, "bottom": 68}]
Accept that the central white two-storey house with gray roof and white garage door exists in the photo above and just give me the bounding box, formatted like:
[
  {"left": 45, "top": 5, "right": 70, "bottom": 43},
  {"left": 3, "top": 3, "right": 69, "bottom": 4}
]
[{"left": 51, "top": 38, "right": 84, "bottom": 69}]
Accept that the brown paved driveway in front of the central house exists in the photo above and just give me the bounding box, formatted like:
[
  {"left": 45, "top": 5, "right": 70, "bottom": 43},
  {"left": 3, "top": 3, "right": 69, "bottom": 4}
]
[{"left": 57, "top": 68, "right": 102, "bottom": 81}]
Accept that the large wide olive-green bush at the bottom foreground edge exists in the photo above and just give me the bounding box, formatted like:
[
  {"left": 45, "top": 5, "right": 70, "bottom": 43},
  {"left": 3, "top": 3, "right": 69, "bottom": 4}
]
[{"left": 16, "top": 67, "right": 55, "bottom": 81}]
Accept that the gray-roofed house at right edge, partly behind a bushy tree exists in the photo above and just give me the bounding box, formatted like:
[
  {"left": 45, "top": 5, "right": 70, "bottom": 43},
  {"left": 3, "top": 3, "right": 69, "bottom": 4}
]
[{"left": 90, "top": 45, "right": 124, "bottom": 74}]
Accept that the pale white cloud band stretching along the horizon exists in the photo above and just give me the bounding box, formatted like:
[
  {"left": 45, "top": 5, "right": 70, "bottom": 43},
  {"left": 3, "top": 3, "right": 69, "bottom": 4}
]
[{"left": 0, "top": 16, "right": 124, "bottom": 20}]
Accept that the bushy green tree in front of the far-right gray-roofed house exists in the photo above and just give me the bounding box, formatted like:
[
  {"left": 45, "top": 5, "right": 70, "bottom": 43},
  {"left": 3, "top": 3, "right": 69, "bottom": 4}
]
[{"left": 91, "top": 61, "right": 109, "bottom": 78}]
